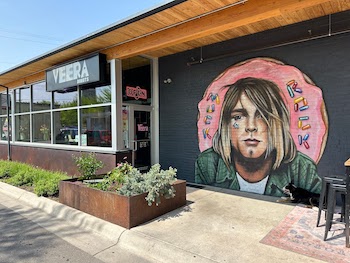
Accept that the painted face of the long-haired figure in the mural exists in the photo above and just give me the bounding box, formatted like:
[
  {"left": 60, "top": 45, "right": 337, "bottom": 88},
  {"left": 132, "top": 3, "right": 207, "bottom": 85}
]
[{"left": 231, "top": 93, "right": 268, "bottom": 158}]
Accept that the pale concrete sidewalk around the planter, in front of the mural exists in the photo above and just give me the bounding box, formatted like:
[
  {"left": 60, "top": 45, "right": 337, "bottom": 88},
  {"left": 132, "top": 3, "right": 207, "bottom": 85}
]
[{"left": 0, "top": 183, "right": 321, "bottom": 263}]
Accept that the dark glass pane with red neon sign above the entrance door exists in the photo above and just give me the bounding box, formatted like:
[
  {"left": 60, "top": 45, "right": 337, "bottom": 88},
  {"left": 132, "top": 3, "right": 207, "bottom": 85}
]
[{"left": 122, "top": 56, "right": 152, "bottom": 105}]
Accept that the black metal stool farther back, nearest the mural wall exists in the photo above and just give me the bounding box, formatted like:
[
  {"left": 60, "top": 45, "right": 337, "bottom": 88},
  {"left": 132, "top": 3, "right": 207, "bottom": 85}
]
[{"left": 316, "top": 175, "right": 346, "bottom": 227}]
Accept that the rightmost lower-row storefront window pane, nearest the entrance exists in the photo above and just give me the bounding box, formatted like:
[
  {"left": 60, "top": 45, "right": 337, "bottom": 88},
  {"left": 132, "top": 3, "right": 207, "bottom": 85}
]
[{"left": 81, "top": 106, "right": 112, "bottom": 147}]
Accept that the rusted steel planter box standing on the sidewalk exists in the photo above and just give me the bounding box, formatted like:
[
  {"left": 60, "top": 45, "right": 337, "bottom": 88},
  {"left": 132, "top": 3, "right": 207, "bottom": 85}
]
[{"left": 59, "top": 179, "right": 186, "bottom": 229}]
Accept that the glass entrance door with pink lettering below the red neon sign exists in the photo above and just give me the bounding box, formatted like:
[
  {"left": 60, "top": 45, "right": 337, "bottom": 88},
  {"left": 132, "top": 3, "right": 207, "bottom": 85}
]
[{"left": 123, "top": 105, "right": 151, "bottom": 171}]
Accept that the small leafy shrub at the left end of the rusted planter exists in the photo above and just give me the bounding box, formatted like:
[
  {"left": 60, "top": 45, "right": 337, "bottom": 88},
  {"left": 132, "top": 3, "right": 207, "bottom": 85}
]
[{"left": 72, "top": 152, "right": 103, "bottom": 180}]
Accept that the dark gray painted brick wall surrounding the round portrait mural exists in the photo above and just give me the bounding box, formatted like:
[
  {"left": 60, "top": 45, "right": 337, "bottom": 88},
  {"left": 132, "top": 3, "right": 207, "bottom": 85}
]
[{"left": 159, "top": 12, "right": 350, "bottom": 182}]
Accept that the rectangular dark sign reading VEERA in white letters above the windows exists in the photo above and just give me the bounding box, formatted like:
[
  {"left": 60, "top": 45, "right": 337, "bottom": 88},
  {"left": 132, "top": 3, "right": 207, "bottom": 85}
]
[{"left": 46, "top": 54, "right": 106, "bottom": 91}]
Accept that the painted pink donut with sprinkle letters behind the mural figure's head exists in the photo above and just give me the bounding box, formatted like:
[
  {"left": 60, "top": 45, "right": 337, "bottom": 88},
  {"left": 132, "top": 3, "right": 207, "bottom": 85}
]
[{"left": 197, "top": 58, "right": 328, "bottom": 163}]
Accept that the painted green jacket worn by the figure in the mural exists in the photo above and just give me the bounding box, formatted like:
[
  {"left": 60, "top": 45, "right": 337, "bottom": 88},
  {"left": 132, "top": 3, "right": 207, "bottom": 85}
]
[{"left": 195, "top": 148, "right": 322, "bottom": 197}]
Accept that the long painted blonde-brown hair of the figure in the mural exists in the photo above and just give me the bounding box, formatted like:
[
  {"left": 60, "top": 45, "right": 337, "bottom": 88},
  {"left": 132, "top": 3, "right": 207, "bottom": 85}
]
[{"left": 213, "top": 77, "right": 297, "bottom": 170}]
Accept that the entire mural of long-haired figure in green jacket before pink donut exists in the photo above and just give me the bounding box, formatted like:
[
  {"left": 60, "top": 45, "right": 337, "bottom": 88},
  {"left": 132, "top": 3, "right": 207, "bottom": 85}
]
[{"left": 195, "top": 58, "right": 328, "bottom": 196}]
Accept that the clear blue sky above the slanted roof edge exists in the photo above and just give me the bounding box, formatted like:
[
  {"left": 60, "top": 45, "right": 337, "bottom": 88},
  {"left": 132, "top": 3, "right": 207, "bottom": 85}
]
[{"left": 0, "top": 0, "right": 171, "bottom": 73}]
